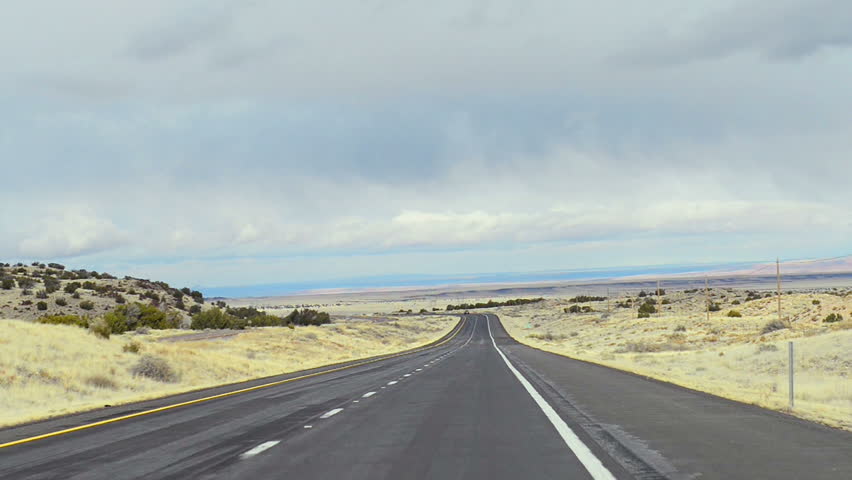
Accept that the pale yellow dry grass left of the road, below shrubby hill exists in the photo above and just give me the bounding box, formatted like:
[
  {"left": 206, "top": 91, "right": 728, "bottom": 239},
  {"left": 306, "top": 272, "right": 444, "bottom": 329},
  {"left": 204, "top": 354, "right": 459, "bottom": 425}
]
[{"left": 0, "top": 316, "right": 458, "bottom": 426}]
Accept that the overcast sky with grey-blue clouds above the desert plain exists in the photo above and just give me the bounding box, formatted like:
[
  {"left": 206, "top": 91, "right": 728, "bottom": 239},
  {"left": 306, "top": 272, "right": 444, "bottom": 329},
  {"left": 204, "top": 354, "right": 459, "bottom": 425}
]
[{"left": 0, "top": 0, "right": 852, "bottom": 286}]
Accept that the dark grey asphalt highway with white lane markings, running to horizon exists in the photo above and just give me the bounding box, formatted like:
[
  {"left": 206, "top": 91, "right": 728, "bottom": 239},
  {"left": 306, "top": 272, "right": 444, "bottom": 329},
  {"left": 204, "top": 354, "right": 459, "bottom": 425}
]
[{"left": 0, "top": 315, "right": 852, "bottom": 480}]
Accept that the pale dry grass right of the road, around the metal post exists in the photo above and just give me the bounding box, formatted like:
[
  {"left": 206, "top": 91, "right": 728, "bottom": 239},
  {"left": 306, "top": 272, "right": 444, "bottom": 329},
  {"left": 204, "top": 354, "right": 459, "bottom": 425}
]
[{"left": 495, "top": 291, "right": 852, "bottom": 430}]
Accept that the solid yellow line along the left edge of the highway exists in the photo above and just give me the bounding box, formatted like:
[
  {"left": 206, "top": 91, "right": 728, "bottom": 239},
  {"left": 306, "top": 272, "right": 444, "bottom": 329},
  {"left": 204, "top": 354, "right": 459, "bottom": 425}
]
[{"left": 0, "top": 317, "right": 467, "bottom": 448}]
